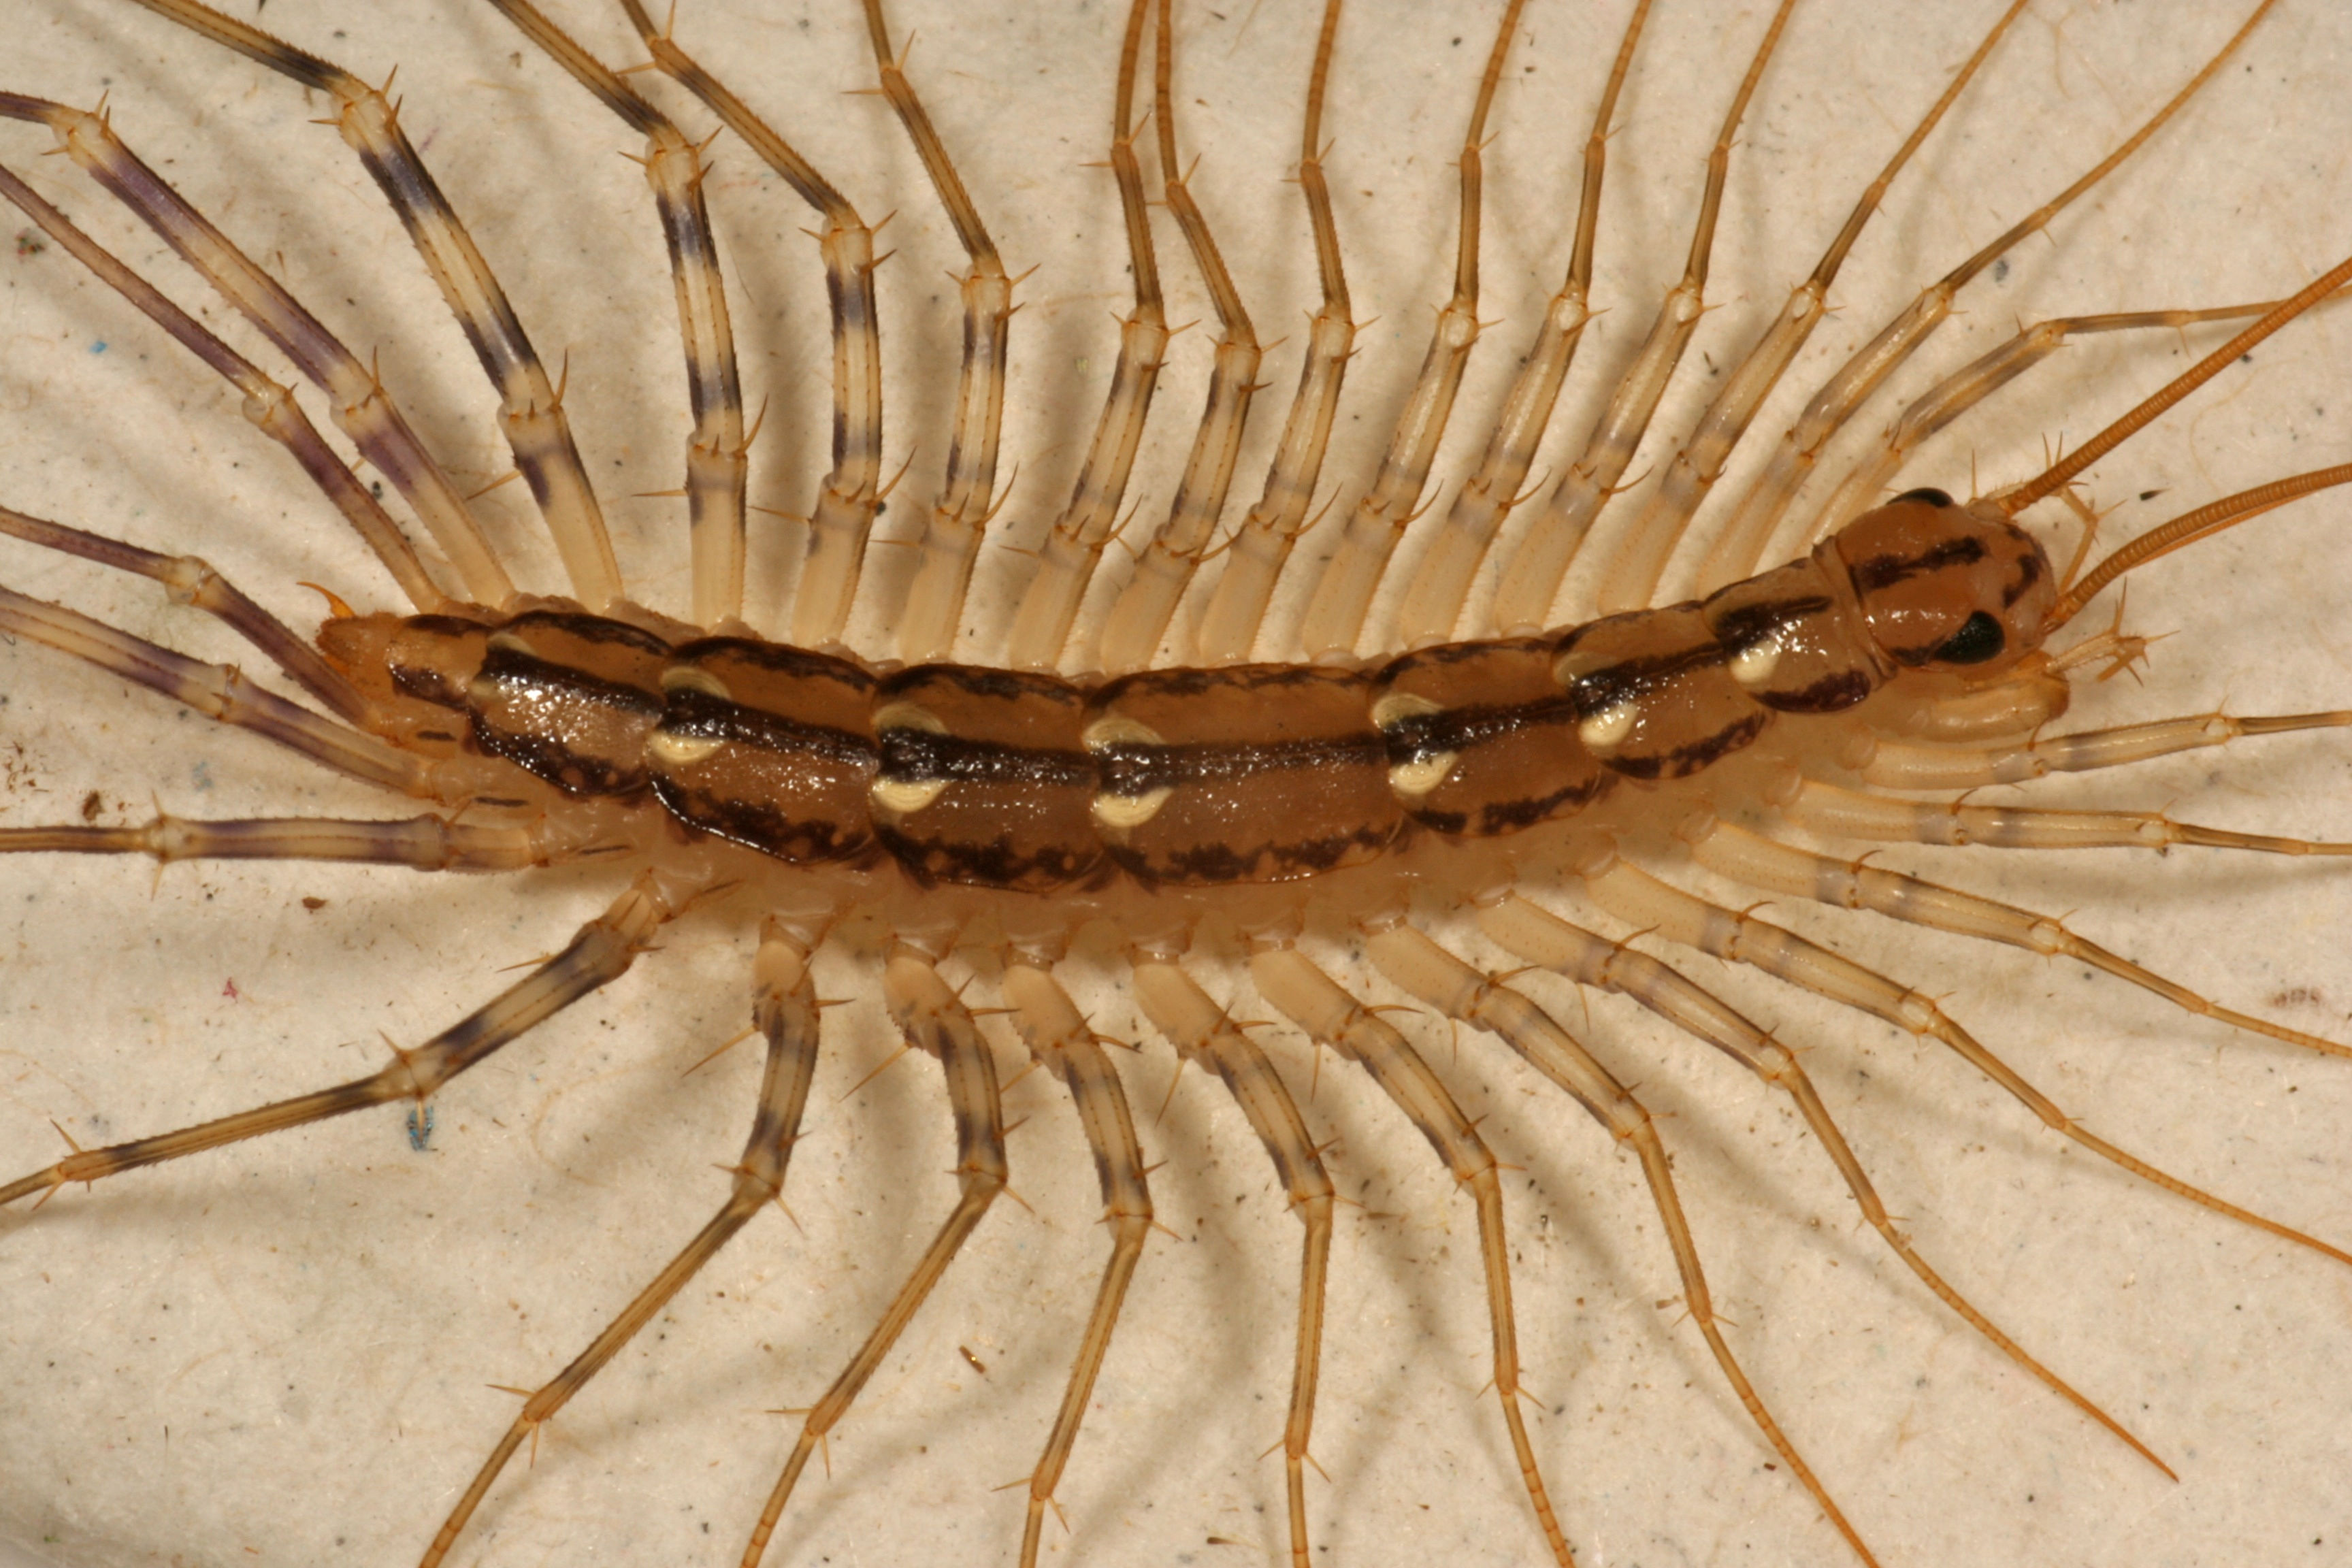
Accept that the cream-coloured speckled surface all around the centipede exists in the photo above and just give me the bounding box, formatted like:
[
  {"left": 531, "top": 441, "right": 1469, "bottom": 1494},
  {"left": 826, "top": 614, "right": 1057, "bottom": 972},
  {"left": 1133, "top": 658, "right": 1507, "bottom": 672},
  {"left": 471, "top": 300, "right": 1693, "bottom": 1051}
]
[{"left": 0, "top": 0, "right": 2352, "bottom": 1568}]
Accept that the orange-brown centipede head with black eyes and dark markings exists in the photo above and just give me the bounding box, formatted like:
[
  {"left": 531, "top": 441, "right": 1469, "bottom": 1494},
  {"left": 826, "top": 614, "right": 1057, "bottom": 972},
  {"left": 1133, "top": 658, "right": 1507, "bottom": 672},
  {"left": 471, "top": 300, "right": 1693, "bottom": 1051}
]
[{"left": 1830, "top": 489, "right": 2058, "bottom": 674}]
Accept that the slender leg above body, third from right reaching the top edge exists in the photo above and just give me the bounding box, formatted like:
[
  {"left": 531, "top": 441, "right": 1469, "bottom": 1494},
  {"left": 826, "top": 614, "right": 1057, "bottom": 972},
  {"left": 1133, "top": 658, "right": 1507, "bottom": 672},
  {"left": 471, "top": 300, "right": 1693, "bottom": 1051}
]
[{"left": 1494, "top": 0, "right": 1792, "bottom": 637}]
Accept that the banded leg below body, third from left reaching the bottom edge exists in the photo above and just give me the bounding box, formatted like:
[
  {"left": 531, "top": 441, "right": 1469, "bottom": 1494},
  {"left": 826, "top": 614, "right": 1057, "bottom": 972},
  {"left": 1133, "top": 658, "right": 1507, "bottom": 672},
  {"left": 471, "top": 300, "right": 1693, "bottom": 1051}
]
[{"left": 1004, "top": 952, "right": 1152, "bottom": 1568}]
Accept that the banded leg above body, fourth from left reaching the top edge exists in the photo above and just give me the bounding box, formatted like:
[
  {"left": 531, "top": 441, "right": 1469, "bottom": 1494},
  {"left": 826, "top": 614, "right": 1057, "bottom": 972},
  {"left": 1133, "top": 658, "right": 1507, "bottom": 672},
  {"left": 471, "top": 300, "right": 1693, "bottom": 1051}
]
[{"left": 866, "top": 0, "right": 1014, "bottom": 666}]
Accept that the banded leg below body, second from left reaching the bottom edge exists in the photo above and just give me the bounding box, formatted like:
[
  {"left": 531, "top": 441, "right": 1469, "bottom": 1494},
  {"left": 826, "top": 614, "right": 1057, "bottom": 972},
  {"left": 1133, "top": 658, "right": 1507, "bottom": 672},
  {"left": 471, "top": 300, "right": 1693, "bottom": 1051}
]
[{"left": 743, "top": 945, "right": 1009, "bottom": 1568}]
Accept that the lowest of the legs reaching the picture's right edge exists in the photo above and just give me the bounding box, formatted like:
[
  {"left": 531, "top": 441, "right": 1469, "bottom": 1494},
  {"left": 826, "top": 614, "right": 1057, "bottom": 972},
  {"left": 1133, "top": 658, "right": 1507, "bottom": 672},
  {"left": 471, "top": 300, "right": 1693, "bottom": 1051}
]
[{"left": 1585, "top": 863, "right": 2352, "bottom": 1269}]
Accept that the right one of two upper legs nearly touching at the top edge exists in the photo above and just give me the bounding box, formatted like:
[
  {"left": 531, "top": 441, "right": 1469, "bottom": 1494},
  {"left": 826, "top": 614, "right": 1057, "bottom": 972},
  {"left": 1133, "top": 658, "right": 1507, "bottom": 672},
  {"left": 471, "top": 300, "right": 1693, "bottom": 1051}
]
[{"left": 1087, "top": 0, "right": 1265, "bottom": 672}]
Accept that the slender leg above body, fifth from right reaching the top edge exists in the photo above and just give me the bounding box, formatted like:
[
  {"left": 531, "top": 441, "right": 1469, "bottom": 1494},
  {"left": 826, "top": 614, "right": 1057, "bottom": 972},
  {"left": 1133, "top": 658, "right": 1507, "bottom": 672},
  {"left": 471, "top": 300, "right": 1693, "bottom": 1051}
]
[{"left": 1298, "top": 0, "right": 1526, "bottom": 661}]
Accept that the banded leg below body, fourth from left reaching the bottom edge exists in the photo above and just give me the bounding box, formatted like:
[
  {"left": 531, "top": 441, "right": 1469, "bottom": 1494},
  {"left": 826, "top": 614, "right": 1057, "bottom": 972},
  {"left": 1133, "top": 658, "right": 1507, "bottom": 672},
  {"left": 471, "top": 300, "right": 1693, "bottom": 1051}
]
[{"left": 1131, "top": 950, "right": 1334, "bottom": 1568}]
